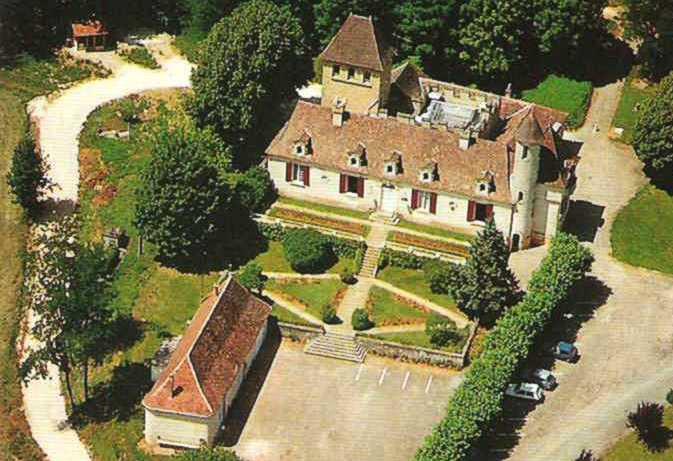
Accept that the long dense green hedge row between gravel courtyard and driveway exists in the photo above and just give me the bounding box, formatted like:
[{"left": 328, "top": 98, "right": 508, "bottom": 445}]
[{"left": 415, "top": 234, "right": 593, "bottom": 461}]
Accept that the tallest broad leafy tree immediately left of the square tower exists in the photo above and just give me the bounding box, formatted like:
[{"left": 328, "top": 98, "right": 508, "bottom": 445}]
[{"left": 189, "top": 0, "right": 311, "bottom": 165}]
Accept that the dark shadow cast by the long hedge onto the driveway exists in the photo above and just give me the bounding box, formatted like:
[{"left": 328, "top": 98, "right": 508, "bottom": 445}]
[{"left": 470, "top": 276, "right": 612, "bottom": 461}]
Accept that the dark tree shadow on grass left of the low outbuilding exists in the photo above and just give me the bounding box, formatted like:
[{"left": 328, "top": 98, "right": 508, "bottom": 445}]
[{"left": 73, "top": 362, "right": 152, "bottom": 427}]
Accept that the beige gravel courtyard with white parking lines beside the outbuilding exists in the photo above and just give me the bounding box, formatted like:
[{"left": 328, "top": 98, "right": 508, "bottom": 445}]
[{"left": 235, "top": 342, "right": 462, "bottom": 461}]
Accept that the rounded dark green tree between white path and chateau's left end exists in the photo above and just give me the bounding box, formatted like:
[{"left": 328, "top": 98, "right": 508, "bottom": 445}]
[{"left": 136, "top": 114, "right": 238, "bottom": 262}]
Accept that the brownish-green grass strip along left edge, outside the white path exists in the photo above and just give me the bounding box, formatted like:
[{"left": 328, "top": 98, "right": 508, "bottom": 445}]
[{"left": 0, "top": 54, "right": 106, "bottom": 460}]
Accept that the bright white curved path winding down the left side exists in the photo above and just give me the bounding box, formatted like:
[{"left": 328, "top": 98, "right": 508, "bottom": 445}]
[{"left": 23, "top": 42, "right": 191, "bottom": 461}]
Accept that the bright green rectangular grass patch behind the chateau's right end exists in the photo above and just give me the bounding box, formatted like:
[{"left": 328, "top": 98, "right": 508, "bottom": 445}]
[{"left": 522, "top": 75, "right": 593, "bottom": 128}]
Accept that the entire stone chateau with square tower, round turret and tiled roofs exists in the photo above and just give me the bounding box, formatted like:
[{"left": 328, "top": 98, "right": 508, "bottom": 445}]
[{"left": 266, "top": 15, "right": 578, "bottom": 251}]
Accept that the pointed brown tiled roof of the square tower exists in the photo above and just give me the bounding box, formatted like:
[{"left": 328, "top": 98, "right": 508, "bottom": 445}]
[{"left": 321, "top": 14, "right": 390, "bottom": 72}]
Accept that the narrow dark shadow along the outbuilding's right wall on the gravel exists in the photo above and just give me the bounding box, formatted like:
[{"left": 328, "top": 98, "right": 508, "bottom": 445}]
[{"left": 217, "top": 317, "right": 282, "bottom": 447}]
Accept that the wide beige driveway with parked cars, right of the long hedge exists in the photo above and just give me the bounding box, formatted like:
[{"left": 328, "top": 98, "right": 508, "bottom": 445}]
[{"left": 509, "top": 83, "right": 673, "bottom": 461}]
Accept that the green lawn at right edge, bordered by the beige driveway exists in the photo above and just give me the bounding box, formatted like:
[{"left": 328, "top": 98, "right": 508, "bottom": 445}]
[{"left": 611, "top": 186, "right": 673, "bottom": 274}]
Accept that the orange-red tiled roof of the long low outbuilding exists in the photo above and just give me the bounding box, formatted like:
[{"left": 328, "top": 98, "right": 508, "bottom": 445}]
[{"left": 143, "top": 277, "right": 271, "bottom": 417}]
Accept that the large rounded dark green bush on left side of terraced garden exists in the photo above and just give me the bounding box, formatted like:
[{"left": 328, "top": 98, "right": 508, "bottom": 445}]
[{"left": 283, "top": 229, "right": 335, "bottom": 274}]
